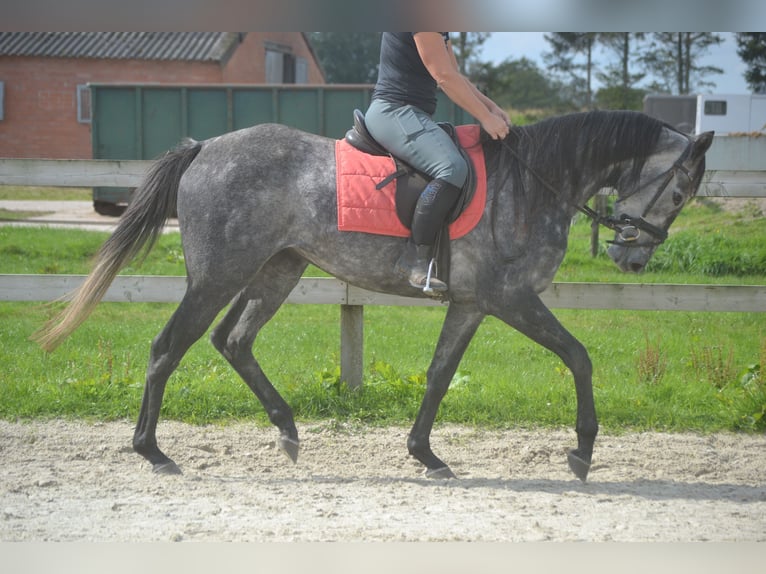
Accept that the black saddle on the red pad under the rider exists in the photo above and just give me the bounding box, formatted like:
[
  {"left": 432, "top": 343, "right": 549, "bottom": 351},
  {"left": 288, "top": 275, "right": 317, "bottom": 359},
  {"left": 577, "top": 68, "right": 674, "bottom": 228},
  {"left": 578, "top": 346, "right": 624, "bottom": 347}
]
[{"left": 346, "top": 110, "right": 476, "bottom": 229}]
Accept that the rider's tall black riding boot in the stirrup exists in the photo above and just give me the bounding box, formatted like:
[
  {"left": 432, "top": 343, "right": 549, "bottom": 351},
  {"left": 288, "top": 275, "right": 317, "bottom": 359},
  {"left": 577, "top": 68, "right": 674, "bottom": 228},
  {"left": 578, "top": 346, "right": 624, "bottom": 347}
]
[{"left": 397, "top": 179, "right": 460, "bottom": 295}]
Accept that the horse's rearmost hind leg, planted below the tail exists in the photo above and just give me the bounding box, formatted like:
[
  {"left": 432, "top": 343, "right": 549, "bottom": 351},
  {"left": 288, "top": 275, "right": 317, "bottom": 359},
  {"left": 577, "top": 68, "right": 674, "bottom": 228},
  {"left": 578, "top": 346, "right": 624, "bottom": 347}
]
[{"left": 133, "top": 284, "right": 238, "bottom": 474}]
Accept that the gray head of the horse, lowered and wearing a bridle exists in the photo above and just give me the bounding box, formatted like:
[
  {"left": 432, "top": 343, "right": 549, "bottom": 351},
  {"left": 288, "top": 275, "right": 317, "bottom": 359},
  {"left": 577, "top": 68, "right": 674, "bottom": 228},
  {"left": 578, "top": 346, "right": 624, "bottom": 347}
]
[{"left": 607, "top": 128, "right": 713, "bottom": 273}]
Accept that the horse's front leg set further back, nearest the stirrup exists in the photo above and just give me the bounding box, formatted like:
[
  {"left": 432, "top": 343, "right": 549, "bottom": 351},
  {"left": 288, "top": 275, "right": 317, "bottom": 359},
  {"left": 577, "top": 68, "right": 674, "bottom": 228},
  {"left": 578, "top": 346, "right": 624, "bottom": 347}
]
[{"left": 407, "top": 303, "right": 484, "bottom": 478}]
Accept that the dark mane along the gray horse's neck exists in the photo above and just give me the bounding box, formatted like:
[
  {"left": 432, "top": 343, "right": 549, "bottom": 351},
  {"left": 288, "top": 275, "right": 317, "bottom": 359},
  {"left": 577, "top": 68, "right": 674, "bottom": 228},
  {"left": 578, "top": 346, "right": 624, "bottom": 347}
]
[{"left": 507, "top": 111, "right": 665, "bottom": 191}]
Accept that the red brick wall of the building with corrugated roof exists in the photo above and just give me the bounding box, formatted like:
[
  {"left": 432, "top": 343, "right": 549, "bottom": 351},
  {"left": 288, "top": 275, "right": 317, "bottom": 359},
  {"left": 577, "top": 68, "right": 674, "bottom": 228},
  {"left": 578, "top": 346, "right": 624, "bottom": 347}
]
[{"left": 0, "top": 32, "right": 324, "bottom": 159}]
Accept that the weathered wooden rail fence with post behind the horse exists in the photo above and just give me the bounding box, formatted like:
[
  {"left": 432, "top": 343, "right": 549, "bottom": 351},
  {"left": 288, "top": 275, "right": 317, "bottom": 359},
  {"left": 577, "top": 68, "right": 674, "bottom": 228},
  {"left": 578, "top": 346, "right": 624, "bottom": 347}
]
[{"left": 0, "top": 159, "right": 766, "bottom": 386}]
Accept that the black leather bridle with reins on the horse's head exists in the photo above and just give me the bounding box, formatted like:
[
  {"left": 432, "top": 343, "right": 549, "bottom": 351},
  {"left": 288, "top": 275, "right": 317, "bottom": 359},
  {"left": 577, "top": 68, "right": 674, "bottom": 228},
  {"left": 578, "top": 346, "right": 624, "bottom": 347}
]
[{"left": 501, "top": 136, "right": 692, "bottom": 247}]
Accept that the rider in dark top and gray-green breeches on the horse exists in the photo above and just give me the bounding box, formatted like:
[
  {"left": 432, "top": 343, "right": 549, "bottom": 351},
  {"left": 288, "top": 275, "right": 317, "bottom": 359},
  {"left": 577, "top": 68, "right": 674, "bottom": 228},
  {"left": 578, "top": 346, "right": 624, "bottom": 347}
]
[{"left": 365, "top": 32, "right": 510, "bottom": 292}]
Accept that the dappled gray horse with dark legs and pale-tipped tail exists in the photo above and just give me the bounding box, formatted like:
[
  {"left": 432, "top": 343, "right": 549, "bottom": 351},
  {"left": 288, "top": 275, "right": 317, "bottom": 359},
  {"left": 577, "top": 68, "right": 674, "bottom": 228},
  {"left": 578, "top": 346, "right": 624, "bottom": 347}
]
[{"left": 36, "top": 112, "right": 713, "bottom": 481}]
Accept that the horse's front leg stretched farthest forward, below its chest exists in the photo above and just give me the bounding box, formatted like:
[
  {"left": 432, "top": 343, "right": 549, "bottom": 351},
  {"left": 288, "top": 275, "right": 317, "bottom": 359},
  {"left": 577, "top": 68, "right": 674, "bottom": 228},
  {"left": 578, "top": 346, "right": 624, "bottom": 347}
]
[{"left": 492, "top": 289, "right": 598, "bottom": 482}]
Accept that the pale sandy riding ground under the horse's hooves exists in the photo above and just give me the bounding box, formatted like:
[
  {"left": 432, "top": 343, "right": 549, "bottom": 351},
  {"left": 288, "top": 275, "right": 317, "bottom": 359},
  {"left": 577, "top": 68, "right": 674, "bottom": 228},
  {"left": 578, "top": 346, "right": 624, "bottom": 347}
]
[{"left": 0, "top": 421, "right": 766, "bottom": 541}]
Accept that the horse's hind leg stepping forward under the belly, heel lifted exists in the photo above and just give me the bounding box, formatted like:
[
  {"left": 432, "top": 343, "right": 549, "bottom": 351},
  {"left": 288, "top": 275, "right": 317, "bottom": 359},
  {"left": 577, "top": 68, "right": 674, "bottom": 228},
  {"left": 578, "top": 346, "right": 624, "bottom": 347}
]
[{"left": 210, "top": 251, "right": 307, "bottom": 462}]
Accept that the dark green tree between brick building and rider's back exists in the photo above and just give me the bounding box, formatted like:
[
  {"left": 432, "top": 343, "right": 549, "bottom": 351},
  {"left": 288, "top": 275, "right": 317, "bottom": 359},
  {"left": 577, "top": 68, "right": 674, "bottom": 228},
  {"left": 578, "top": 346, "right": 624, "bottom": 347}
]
[{"left": 309, "top": 32, "right": 380, "bottom": 84}]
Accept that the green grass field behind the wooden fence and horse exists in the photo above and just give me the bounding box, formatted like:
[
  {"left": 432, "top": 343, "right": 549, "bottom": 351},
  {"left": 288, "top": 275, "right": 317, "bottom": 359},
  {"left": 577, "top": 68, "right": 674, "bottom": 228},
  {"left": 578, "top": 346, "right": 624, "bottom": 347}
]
[{"left": 0, "top": 198, "right": 766, "bottom": 432}]
